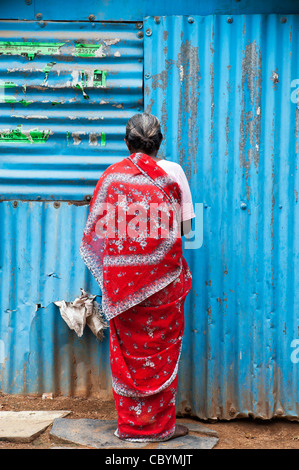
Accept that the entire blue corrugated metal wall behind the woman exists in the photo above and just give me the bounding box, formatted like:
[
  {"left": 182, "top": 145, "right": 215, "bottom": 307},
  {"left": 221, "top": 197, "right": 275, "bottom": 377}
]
[{"left": 0, "top": 7, "right": 299, "bottom": 419}]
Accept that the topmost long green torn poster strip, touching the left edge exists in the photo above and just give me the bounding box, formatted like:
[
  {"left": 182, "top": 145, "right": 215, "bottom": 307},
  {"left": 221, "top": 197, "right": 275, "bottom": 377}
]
[{"left": 0, "top": 41, "right": 64, "bottom": 60}]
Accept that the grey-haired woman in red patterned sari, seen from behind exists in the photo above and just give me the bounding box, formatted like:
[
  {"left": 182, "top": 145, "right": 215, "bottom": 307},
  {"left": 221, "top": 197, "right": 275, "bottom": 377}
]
[{"left": 80, "top": 113, "right": 192, "bottom": 442}]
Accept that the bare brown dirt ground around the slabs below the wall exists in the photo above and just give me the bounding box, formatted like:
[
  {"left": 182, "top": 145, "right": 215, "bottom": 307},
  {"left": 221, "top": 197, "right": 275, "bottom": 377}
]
[{"left": 0, "top": 394, "right": 299, "bottom": 450}]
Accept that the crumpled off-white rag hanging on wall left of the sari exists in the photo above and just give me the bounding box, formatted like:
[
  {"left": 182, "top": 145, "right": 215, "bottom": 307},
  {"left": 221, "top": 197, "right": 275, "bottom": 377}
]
[{"left": 54, "top": 288, "right": 107, "bottom": 341}]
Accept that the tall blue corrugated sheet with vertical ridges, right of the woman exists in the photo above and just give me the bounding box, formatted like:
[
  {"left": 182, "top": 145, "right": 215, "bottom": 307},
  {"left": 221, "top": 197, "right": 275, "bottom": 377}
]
[{"left": 144, "top": 15, "right": 299, "bottom": 419}]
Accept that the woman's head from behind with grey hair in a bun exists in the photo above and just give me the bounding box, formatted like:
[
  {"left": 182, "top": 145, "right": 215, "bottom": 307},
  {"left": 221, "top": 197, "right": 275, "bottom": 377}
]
[{"left": 125, "top": 113, "right": 163, "bottom": 155}]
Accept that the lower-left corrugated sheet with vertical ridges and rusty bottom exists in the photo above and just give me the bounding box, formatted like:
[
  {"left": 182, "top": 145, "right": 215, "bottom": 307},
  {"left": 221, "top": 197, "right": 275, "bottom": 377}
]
[{"left": 0, "top": 201, "right": 112, "bottom": 399}]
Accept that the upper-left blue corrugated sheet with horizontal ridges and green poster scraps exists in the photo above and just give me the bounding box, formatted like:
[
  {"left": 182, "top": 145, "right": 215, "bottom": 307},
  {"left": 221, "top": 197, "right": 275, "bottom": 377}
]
[{"left": 0, "top": 21, "right": 143, "bottom": 200}]
